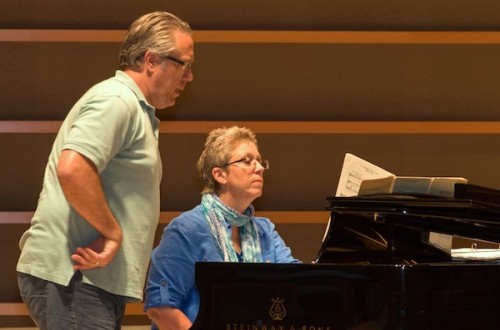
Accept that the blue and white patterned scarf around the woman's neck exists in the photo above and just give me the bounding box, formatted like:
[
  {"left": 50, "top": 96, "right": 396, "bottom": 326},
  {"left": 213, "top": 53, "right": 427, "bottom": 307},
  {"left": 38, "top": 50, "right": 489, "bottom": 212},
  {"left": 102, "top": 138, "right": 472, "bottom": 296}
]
[{"left": 201, "top": 194, "right": 262, "bottom": 262}]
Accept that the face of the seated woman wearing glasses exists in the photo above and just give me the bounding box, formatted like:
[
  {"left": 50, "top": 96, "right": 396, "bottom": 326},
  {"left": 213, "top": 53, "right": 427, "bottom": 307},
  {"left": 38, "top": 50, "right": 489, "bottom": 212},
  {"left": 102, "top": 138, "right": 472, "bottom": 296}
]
[{"left": 223, "top": 141, "right": 264, "bottom": 205}]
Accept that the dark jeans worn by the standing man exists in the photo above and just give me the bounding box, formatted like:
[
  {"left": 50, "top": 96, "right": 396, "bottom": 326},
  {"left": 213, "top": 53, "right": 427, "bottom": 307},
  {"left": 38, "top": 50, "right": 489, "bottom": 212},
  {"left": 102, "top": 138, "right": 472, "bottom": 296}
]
[{"left": 17, "top": 271, "right": 126, "bottom": 330}]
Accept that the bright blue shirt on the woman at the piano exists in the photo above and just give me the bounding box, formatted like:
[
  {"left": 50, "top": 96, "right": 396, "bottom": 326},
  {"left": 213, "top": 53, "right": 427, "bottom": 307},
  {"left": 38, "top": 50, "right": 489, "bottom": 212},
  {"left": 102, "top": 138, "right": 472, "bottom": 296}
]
[{"left": 144, "top": 205, "right": 300, "bottom": 322}]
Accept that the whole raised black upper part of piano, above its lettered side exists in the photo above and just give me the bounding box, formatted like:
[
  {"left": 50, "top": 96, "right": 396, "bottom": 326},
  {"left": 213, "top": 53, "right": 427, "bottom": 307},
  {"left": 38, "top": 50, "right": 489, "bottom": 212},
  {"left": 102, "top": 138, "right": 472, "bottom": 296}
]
[{"left": 316, "top": 192, "right": 500, "bottom": 264}]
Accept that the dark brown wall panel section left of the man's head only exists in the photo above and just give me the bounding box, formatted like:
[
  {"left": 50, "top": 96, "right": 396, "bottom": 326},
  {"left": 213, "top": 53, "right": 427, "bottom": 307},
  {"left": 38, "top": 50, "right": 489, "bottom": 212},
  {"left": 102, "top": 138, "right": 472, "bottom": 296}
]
[{"left": 0, "top": 42, "right": 119, "bottom": 120}]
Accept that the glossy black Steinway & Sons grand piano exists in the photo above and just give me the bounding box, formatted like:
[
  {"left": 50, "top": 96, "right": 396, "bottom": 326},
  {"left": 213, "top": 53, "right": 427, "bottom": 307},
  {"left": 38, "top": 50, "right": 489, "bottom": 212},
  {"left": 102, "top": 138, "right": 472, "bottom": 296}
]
[{"left": 192, "top": 184, "right": 500, "bottom": 330}]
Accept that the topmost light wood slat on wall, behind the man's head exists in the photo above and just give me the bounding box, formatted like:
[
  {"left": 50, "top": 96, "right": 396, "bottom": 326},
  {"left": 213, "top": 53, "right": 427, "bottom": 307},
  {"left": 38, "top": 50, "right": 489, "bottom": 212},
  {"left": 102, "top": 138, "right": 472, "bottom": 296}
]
[{"left": 0, "top": 29, "right": 500, "bottom": 45}]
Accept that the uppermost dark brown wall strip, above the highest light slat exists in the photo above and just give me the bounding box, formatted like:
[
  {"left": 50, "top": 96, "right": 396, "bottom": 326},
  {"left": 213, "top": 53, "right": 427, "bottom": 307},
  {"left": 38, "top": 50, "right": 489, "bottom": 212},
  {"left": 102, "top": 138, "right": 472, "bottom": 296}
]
[{"left": 0, "top": 0, "right": 500, "bottom": 30}]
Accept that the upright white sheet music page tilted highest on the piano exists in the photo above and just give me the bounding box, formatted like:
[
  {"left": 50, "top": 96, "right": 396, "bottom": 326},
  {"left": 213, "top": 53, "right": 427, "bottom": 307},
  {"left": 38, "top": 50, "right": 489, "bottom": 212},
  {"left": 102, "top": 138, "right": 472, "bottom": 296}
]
[{"left": 335, "top": 153, "right": 394, "bottom": 197}]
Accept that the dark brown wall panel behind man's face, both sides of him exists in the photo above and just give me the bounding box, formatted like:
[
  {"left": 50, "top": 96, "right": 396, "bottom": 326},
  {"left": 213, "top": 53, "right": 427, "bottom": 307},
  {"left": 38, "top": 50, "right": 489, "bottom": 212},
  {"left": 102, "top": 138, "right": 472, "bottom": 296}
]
[{"left": 0, "top": 42, "right": 500, "bottom": 121}]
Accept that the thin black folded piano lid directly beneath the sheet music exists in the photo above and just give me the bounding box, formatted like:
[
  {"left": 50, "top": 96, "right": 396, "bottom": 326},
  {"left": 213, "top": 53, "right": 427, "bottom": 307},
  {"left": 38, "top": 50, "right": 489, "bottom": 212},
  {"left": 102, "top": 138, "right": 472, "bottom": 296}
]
[{"left": 328, "top": 196, "right": 500, "bottom": 243}]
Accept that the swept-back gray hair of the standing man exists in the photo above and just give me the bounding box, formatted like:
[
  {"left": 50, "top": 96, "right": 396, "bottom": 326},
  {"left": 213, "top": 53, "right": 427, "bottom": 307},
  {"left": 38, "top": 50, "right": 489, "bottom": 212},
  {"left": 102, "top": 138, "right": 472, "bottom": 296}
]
[{"left": 119, "top": 11, "right": 193, "bottom": 70}]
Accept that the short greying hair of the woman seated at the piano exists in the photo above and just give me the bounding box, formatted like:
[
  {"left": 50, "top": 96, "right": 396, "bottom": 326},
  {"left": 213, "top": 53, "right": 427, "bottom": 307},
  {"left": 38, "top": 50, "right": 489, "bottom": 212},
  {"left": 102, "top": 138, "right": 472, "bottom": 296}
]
[{"left": 197, "top": 126, "right": 257, "bottom": 194}]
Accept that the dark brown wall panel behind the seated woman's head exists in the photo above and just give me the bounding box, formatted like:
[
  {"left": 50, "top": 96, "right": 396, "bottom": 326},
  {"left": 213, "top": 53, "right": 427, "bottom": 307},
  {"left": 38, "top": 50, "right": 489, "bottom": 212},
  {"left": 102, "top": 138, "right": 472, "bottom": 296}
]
[{"left": 0, "top": 131, "right": 500, "bottom": 211}]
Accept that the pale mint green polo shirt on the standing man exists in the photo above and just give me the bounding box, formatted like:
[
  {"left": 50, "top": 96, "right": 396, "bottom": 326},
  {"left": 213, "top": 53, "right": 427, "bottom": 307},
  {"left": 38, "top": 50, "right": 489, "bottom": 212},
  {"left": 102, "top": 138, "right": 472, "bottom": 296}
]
[{"left": 17, "top": 71, "right": 162, "bottom": 301}]
